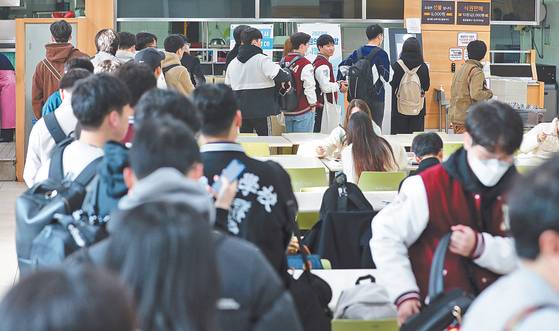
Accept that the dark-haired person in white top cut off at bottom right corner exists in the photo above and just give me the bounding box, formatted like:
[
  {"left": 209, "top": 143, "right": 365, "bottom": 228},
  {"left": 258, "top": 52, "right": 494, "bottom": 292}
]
[{"left": 462, "top": 156, "right": 559, "bottom": 331}]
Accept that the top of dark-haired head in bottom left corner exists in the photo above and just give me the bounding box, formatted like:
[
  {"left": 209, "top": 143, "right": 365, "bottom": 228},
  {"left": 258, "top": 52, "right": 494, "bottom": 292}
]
[{"left": 0, "top": 266, "right": 137, "bottom": 331}]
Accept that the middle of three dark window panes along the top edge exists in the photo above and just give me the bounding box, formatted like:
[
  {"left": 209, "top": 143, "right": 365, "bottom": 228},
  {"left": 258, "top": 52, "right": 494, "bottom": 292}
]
[{"left": 260, "top": 0, "right": 360, "bottom": 19}]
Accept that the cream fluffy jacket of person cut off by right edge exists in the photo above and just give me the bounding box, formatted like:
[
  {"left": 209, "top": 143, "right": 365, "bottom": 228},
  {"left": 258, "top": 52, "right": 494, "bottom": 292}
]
[{"left": 520, "top": 118, "right": 559, "bottom": 159}]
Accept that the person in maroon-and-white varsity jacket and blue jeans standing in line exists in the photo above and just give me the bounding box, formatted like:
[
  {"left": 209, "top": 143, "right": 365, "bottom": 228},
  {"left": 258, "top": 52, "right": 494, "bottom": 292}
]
[{"left": 284, "top": 32, "right": 317, "bottom": 133}]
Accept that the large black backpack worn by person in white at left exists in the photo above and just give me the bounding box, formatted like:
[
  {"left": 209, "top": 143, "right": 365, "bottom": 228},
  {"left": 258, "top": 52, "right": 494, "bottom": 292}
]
[{"left": 16, "top": 138, "right": 104, "bottom": 275}]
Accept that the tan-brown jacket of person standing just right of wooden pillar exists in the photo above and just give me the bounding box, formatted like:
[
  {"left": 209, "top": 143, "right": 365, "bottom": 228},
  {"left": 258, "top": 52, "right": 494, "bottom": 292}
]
[{"left": 449, "top": 60, "right": 493, "bottom": 124}]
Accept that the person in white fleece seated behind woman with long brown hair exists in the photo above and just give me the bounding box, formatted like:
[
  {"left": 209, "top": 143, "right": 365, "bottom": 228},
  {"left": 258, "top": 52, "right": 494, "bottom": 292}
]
[{"left": 316, "top": 99, "right": 407, "bottom": 164}]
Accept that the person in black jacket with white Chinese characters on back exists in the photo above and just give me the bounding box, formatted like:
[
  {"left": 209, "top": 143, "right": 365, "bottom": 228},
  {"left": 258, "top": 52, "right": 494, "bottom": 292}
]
[{"left": 194, "top": 84, "right": 296, "bottom": 282}]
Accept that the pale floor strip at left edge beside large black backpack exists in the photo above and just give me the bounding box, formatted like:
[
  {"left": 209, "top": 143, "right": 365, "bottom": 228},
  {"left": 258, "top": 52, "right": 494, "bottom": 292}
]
[{"left": 0, "top": 182, "right": 27, "bottom": 297}]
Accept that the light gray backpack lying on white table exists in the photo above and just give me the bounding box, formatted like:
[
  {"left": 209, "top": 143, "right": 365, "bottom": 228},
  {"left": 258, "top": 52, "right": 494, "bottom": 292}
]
[{"left": 334, "top": 275, "right": 397, "bottom": 320}]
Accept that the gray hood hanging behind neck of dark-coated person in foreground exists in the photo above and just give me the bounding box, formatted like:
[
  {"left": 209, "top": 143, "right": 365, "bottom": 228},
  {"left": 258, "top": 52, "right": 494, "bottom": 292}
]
[{"left": 117, "top": 168, "right": 215, "bottom": 226}]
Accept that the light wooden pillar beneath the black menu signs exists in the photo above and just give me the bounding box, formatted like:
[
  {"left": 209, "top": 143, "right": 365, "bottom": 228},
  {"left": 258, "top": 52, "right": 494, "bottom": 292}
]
[{"left": 404, "top": 0, "right": 491, "bottom": 129}]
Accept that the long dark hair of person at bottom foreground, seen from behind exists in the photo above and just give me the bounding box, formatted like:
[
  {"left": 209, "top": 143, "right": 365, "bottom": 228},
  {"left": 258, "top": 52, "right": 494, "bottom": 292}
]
[{"left": 108, "top": 202, "right": 219, "bottom": 331}]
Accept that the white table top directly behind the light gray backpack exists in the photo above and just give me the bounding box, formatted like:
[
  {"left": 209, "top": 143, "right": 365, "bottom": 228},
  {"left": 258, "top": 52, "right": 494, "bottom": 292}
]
[{"left": 294, "top": 269, "right": 377, "bottom": 310}]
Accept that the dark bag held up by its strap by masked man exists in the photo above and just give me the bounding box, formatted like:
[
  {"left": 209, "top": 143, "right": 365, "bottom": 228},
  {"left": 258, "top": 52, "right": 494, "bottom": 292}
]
[{"left": 400, "top": 233, "right": 474, "bottom": 331}]
